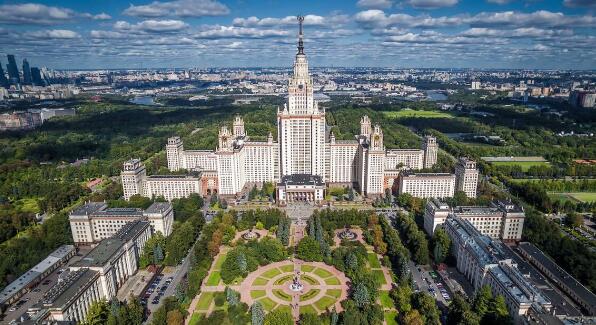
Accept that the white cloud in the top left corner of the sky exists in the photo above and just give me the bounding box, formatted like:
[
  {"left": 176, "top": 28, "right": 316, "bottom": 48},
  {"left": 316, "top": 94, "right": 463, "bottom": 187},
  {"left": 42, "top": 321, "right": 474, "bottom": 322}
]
[{"left": 0, "top": 3, "right": 76, "bottom": 25}]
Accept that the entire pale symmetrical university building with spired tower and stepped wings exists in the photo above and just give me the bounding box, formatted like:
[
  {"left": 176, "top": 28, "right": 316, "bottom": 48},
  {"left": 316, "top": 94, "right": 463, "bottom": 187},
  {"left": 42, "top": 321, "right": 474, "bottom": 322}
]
[{"left": 122, "top": 19, "right": 477, "bottom": 205}]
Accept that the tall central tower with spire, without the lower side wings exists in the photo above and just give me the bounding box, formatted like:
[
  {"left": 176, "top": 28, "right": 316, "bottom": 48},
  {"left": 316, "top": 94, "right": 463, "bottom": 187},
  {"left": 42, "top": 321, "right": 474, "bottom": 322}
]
[{"left": 277, "top": 16, "right": 326, "bottom": 180}]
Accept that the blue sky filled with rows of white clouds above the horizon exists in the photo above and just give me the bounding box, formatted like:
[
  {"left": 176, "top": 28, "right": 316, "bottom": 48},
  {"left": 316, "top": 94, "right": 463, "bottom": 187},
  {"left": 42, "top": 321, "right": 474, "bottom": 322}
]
[{"left": 0, "top": 0, "right": 596, "bottom": 69}]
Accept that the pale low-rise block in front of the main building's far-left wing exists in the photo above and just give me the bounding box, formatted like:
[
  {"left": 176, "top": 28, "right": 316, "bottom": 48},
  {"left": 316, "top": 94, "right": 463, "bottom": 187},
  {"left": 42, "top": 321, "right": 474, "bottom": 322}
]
[{"left": 69, "top": 202, "right": 174, "bottom": 244}]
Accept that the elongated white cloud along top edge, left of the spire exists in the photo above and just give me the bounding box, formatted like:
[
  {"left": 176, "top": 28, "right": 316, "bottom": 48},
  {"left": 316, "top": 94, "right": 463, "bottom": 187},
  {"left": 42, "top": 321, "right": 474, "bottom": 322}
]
[{"left": 123, "top": 0, "right": 230, "bottom": 18}]
